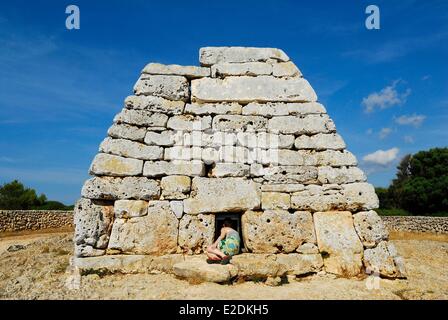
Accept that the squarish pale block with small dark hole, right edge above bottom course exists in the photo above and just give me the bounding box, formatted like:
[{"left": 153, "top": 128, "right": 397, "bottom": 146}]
[{"left": 342, "top": 182, "right": 379, "bottom": 210}]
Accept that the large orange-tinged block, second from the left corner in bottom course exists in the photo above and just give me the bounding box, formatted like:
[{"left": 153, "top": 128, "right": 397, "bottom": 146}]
[{"left": 108, "top": 201, "right": 179, "bottom": 255}]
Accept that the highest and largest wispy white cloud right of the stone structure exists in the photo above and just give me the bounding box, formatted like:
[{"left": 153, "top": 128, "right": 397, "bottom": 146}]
[{"left": 361, "top": 80, "right": 411, "bottom": 113}]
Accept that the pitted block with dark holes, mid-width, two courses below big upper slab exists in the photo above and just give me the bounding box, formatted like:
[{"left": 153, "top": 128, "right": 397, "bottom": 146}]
[{"left": 212, "top": 115, "right": 267, "bottom": 131}]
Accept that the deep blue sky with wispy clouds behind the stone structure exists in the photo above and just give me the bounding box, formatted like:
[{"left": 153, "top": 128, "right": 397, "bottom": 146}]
[{"left": 0, "top": 0, "right": 448, "bottom": 204}]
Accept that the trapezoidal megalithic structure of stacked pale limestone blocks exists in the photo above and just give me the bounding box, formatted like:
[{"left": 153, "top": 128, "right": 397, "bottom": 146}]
[{"left": 74, "top": 47, "right": 405, "bottom": 282}]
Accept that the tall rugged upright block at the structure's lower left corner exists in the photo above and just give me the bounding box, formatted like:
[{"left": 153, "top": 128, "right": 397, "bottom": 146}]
[{"left": 73, "top": 198, "right": 114, "bottom": 257}]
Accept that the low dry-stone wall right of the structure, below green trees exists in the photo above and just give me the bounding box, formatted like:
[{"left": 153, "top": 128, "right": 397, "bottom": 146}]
[{"left": 381, "top": 216, "right": 448, "bottom": 234}]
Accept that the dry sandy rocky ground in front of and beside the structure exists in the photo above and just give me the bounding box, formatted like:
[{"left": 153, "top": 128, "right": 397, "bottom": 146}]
[{"left": 0, "top": 232, "right": 448, "bottom": 299}]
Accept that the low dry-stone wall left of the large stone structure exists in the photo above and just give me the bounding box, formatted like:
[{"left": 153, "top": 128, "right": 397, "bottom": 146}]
[{"left": 0, "top": 210, "right": 73, "bottom": 232}]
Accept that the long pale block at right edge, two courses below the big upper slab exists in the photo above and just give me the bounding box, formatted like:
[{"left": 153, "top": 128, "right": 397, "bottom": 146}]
[{"left": 268, "top": 114, "right": 334, "bottom": 135}]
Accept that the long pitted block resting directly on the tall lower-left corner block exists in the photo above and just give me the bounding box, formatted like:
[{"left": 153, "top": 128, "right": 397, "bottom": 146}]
[{"left": 81, "top": 177, "right": 160, "bottom": 200}]
